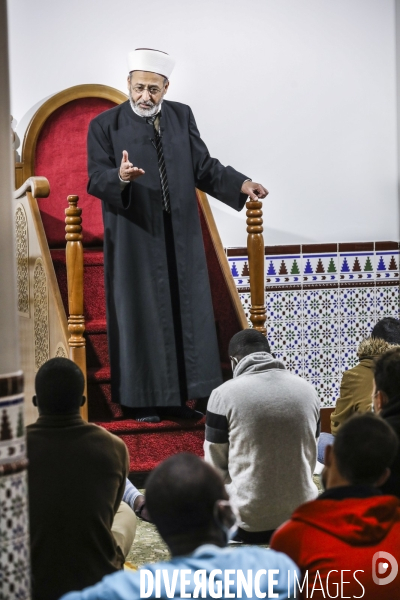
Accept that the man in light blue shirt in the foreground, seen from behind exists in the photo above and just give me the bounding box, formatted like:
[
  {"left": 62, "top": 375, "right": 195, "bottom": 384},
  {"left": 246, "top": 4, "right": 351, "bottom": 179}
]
[{"left": 62, "top": 453, "right": 300, "bottom": 600}]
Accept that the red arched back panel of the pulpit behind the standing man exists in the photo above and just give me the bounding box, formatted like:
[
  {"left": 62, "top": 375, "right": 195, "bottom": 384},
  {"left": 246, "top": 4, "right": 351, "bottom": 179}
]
[{"left": 35, "top": 98, "right": 115, "bottom": 248}]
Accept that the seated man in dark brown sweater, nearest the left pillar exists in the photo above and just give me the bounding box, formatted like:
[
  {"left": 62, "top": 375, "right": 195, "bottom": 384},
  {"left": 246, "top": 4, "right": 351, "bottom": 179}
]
[{"left": 26, "top": 358, "right": 138, "bottom": 600}]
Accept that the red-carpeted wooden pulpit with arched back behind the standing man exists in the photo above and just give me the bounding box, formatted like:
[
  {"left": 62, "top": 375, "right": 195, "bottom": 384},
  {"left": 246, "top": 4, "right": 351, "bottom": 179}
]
[{"left": 16, "top": 85, "right": 247, "bottom": 471}]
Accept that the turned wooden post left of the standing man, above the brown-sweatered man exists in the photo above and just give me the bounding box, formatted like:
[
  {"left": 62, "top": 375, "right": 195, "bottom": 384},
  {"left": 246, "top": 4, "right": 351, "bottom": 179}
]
[{"left": 65, "top": 196, "right": 88, "bottom": 420}]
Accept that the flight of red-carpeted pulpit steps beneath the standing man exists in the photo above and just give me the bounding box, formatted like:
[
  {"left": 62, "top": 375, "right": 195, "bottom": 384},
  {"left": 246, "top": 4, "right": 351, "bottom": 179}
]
[{"left": 51, "top": 249, "right": 206, "bottom": 473}]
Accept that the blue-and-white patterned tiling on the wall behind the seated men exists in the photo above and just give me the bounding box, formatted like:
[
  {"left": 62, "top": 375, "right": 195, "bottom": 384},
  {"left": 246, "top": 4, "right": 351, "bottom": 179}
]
[{"left": 227, "top": 242, "right": 399, "bottom": 407}]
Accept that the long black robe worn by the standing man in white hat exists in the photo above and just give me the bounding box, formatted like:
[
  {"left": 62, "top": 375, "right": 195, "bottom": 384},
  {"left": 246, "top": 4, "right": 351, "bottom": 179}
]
[{"left": 88, "top": 101, "right": 247, "bottom": 407}]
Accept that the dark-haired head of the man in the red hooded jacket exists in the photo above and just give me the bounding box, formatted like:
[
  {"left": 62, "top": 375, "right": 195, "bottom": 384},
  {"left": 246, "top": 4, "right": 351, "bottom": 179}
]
[{"left": 333, "top": 413, "right": 399, "bottom": 485}]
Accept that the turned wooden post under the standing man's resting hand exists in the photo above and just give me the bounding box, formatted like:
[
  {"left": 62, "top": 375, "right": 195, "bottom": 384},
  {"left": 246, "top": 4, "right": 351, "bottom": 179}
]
[{"left": 246, "top": 198, "right": 267, "bottom": 335}]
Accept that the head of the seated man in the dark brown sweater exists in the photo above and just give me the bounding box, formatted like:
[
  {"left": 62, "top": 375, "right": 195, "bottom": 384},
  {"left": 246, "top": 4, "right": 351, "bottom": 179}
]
[{"left": 35, "top": 358, "right": 85, "bottom": 414}]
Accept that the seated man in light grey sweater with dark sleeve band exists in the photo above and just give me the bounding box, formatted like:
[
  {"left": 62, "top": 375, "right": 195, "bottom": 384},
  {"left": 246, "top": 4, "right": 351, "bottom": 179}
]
[{"left": 204, "top": 329, "right": 319, "bottom": 544}]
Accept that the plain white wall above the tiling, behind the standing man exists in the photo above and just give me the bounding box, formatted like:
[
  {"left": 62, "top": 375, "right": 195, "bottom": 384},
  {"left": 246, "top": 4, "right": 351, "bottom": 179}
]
[{"left": 9, "top": 0, "right": 399, "bottom": 246}]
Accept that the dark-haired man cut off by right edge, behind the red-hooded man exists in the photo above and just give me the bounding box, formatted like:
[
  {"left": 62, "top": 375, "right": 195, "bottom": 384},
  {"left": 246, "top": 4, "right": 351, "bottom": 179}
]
[{"left": 372, "top": 348, "right": 400, "bottom": 498}]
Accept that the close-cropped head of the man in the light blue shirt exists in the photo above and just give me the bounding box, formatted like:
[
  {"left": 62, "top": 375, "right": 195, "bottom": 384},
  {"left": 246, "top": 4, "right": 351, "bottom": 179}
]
[{"left": 146, "top": 452, "right": 227, "bottom": 539}]
